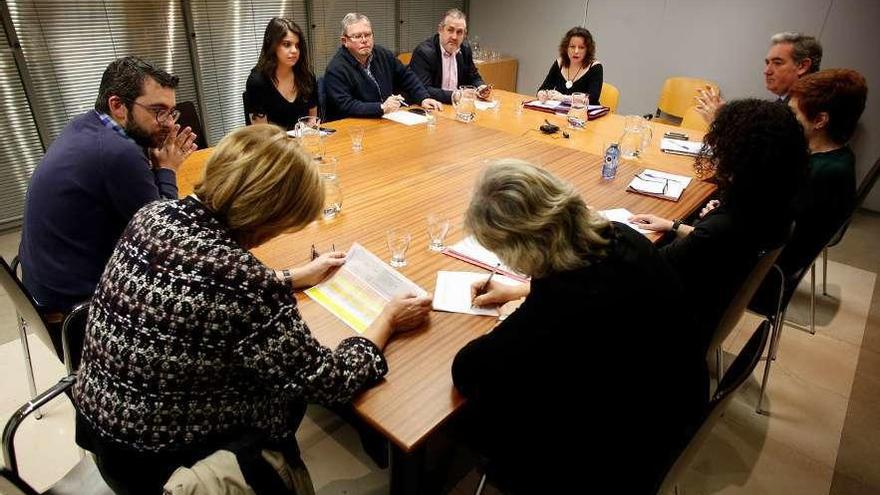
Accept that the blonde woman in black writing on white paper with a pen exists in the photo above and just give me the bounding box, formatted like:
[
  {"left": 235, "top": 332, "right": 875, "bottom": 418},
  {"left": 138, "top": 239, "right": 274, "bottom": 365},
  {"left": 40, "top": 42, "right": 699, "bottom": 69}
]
[{"left": 452, "top": 160, "right": 708, "bottom": 493}]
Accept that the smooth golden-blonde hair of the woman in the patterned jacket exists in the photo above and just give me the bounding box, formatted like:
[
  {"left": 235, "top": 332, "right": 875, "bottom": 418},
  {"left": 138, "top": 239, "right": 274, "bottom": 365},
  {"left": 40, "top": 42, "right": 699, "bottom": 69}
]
[{"left": 195, "top": 124, "right": 324, "bottom": 247}]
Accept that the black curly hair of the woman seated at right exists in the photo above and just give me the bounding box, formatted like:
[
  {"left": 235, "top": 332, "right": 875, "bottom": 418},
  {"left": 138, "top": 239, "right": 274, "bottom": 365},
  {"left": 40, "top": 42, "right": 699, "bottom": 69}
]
[{"left": 694, "top": 99, "right": 809, "bottom": 213}]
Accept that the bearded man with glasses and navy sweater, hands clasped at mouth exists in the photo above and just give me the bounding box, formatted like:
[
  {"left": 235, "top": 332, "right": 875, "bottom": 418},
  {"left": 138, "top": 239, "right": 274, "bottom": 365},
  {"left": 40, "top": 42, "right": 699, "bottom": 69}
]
[{"left": 19, "top": 57, "right": 196, "bottom": 357}]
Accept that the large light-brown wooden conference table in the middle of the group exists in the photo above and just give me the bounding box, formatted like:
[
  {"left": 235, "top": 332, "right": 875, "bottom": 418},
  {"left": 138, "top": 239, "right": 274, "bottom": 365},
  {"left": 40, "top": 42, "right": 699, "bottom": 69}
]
[{"left": 178, "top": 91, "right": 714, "bottom": 493}]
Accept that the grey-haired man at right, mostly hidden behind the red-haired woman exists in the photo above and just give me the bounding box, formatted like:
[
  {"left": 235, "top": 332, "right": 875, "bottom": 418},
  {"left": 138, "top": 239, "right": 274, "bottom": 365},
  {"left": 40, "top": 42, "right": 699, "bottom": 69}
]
[{"left": 697, "top": 32, "right": 822, "bottom": 123}]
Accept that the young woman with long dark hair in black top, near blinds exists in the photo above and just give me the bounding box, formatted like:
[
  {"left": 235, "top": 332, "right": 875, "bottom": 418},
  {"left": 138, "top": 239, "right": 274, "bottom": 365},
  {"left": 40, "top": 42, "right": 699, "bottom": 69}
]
[{"left": 245, "top": 17, "right": 318, "bottom": 129}]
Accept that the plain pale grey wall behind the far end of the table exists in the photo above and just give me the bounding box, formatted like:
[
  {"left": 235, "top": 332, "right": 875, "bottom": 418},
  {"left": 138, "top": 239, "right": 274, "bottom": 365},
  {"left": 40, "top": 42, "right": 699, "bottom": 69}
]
[{"left": 468, "top": 0, "right": 880, "bottom": 211}]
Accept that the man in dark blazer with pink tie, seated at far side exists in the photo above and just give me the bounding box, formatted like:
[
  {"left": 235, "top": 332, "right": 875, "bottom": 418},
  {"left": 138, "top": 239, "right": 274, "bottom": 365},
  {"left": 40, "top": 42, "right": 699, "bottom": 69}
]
[{"left": 409, "top": 9, "right": 488, "bottom": 103}]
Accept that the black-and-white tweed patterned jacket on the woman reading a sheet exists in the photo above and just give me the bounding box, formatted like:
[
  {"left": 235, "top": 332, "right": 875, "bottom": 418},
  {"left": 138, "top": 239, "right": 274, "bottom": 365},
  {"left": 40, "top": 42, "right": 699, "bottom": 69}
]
[{"left": 74, "top": 197, "right": 388, "bottom": 452}]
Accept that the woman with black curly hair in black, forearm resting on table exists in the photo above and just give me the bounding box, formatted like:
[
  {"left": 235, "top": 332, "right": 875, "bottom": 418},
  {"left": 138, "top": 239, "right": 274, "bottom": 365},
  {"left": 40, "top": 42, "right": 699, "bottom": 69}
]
[{"left": 632, "top": 99, "right": 807, "bottom": 351}]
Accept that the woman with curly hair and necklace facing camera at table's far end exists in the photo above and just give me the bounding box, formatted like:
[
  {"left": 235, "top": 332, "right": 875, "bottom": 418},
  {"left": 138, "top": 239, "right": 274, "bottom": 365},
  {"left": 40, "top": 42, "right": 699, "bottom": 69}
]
[{"left": 538, "top": 27, "right": 602, "bottom": 105}]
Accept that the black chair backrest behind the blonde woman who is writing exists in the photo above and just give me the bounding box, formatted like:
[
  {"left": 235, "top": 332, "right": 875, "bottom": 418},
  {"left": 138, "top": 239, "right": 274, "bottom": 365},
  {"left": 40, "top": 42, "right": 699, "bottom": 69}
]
[{"left": 657, "top": 321, "right": 770, "bottom": 495}]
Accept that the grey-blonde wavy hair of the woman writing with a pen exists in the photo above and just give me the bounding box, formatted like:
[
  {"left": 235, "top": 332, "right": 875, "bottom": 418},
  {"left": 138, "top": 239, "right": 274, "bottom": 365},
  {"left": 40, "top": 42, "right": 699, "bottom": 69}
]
[{"left": 465, "top": 159, "right": 610, "bottom": 277}]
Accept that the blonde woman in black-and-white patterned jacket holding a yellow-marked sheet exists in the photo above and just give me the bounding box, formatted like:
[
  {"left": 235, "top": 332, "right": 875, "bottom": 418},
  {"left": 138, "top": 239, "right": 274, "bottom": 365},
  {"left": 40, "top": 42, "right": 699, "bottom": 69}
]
[{"left": 74, "top": 124, "right": 431, "bottom": 495}]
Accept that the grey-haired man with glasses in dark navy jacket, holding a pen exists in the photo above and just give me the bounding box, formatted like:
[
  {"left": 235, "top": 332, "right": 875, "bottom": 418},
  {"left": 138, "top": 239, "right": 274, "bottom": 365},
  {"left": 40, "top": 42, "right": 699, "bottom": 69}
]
[{"left": 324, "top": 13, "right": 441, "bottom": 120}]
